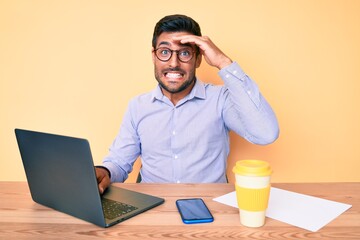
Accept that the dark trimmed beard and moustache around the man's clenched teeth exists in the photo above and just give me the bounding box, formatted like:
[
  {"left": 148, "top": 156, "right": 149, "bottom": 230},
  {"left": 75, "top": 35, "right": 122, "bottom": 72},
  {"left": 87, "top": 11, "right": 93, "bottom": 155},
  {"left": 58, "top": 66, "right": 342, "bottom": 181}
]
[{"left": 155, "top": 67, "right": 196, "bottom": 94}]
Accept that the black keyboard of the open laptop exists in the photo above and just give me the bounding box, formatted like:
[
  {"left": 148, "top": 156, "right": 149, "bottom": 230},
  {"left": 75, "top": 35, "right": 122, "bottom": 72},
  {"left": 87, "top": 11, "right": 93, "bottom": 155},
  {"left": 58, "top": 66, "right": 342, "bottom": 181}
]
[{"left": 101, "top": 198, "right": 138, "bottom": 219}]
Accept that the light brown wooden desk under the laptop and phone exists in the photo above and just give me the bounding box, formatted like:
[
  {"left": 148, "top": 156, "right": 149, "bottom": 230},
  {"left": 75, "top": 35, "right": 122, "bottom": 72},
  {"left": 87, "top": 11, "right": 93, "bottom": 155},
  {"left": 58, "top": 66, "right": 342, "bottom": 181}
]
[{"left": 0, "top": 182, "right": 360, "bottom": 240}]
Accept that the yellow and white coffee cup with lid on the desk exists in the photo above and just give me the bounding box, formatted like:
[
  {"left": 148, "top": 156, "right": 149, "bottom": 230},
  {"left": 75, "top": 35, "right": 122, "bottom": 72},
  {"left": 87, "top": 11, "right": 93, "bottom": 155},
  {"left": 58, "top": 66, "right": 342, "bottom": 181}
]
[{"left": 233, "top": 160, "right": 272, "bottom": 227}]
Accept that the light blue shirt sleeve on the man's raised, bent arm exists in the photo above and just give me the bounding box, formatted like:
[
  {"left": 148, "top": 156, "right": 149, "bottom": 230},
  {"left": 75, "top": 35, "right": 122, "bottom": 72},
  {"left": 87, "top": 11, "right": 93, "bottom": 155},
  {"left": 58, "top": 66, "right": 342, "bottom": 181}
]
[{"left": 219, "top": 62, "right": 279, "bottom": 145}]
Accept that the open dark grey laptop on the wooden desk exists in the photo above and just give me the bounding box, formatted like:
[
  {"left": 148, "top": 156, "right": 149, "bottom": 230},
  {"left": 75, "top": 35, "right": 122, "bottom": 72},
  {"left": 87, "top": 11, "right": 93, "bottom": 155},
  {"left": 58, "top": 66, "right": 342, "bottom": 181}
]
[{"left": 15, "top": 129, "right": 164, "bottom": 227}]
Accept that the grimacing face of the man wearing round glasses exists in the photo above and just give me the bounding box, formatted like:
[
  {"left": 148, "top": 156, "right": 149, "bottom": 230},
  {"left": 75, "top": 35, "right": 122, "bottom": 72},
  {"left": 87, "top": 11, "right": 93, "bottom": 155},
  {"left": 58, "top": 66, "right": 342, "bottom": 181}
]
[{"left": 152, "top": 32, "right": 201, "bottom": 94}]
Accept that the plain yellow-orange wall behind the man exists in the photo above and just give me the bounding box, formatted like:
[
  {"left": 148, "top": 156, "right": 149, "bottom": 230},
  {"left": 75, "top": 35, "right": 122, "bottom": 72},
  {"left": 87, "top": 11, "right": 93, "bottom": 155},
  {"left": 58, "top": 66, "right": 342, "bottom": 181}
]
[{"left": 0, "top": 0, "right": 360, "bottom": 182}]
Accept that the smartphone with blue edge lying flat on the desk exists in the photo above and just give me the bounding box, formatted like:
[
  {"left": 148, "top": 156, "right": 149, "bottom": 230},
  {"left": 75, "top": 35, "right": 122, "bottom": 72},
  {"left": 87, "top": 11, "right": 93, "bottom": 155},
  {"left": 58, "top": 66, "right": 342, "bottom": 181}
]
[{"left": 176, "top": 198, "right": 214, "bottom": 224}]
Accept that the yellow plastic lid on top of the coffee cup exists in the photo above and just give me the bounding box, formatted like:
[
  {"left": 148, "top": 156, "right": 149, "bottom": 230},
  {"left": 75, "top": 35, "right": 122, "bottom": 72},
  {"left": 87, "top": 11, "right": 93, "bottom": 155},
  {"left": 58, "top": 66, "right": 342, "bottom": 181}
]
[{"left": 233, "top": 160, "right": 272, "bottom": 177}]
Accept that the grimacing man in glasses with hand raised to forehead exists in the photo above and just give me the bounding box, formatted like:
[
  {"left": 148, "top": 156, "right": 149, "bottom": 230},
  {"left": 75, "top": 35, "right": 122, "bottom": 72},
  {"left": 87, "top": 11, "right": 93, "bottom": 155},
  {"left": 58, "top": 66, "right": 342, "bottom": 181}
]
[{"left": 96, "top": 15, "right": 279, "bottom": 192}]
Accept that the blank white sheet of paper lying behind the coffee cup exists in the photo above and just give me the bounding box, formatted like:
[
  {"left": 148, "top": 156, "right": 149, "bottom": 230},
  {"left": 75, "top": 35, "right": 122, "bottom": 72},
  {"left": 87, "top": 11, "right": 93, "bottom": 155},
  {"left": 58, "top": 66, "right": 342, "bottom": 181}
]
[{"left": 213, "top": 187, "right": 351, "bottom": 232}]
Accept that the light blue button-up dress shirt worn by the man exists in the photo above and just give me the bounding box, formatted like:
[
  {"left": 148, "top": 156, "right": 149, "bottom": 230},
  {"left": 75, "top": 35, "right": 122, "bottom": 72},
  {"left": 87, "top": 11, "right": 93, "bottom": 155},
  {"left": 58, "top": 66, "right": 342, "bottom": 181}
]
[{"left": 103, "top": 62, "right": 279, "bottom": 183}]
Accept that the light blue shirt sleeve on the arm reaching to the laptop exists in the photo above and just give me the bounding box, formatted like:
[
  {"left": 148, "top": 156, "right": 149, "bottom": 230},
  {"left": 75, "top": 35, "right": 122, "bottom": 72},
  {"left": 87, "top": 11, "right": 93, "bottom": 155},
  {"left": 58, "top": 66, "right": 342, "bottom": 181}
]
[{"left": 103, "top": 101, "right": 140, "bottom": 182}]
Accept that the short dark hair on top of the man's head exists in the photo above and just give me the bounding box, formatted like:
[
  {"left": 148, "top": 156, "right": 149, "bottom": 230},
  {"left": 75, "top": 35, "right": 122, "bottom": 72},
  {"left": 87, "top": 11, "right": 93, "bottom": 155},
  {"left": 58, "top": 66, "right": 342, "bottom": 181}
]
[{"left": 152, "top": 14, "right": 201, "bottom": 53}]
